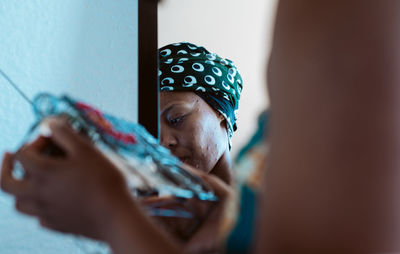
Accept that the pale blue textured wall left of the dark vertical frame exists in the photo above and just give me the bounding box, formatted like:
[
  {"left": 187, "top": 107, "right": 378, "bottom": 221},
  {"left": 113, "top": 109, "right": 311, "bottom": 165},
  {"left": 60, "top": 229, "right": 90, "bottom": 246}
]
[{"left": 0, "top": 0, "right": 138, "bottom": 254}]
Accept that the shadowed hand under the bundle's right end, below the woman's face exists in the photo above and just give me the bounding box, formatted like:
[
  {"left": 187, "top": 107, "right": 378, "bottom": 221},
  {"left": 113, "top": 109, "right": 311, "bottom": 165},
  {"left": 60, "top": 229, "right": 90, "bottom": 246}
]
[{"left": 140, "top": 170, "right": 234, "bottom": 252}]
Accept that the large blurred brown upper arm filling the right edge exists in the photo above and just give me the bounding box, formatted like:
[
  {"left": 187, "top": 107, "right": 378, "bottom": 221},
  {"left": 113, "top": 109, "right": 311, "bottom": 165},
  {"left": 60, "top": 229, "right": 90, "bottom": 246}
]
[{"left": 257, "top": 0, "right": 400, "bottom": 253}]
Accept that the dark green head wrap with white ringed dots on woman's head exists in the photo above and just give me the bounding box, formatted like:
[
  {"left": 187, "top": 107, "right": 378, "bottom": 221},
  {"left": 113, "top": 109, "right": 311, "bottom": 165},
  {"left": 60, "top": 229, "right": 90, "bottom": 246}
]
[{"left": 158, "top": 42, "right": 243, "bottom": 144}]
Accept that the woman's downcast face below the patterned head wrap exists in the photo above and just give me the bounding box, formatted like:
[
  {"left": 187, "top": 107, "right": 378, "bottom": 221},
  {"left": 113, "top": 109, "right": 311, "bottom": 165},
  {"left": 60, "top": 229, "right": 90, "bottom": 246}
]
[{"left": 160, "top": 92, "right": 228, "bottom": 173}]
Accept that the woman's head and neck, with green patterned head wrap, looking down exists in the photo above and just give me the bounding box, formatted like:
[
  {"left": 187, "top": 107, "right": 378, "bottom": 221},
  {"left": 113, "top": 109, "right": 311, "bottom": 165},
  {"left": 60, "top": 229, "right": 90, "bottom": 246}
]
[{"left": 159, "top": 42, "right": 243, "bottom": 184}]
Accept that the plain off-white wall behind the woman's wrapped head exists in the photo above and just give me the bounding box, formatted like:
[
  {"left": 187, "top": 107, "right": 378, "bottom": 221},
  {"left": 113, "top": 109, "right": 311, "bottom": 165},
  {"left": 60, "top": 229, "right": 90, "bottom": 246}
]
[{"left": 158, "top": 0, "right": 276, "bottom": 154}]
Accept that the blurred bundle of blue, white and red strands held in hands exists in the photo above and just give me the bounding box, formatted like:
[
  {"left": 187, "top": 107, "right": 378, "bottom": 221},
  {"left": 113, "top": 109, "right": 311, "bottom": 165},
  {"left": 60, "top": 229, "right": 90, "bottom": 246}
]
[{"left": 29, "top": 94, "right": 217, "bottom": 208}]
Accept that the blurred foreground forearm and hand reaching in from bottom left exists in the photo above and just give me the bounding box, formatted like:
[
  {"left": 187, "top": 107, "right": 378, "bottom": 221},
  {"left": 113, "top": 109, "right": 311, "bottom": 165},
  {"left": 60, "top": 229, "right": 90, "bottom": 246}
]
[{"left": 1, "top": 121, "right": 183, "bottom": 254}]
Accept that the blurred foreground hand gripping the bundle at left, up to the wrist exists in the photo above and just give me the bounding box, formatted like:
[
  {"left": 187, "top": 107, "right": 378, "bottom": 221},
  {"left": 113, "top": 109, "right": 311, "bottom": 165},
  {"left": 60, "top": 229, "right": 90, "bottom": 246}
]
[{"left": 1, "top": 119, "right": 132, "bottom": 239}]
